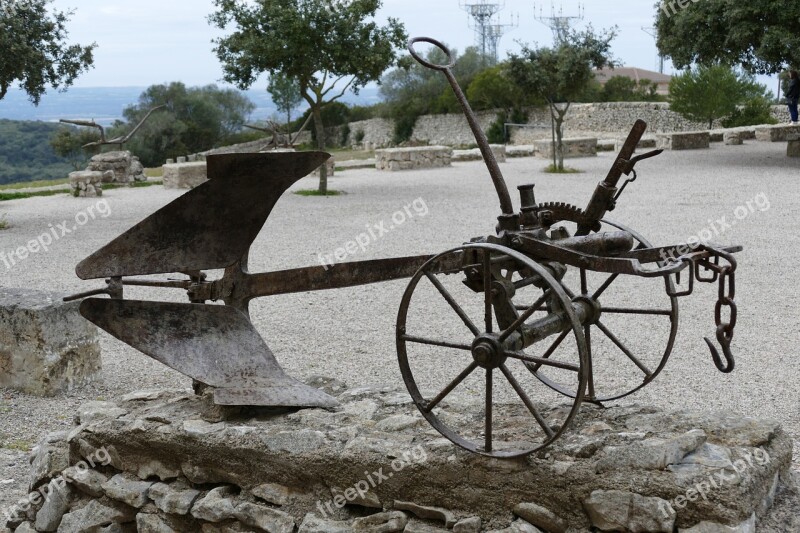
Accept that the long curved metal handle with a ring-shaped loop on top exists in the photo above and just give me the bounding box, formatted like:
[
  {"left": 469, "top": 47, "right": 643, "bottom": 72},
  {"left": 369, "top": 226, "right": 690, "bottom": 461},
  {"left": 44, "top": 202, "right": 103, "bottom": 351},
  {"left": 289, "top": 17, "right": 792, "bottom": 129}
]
[{"left": 408, "top": 37, "right": 514, "bottom": 216}]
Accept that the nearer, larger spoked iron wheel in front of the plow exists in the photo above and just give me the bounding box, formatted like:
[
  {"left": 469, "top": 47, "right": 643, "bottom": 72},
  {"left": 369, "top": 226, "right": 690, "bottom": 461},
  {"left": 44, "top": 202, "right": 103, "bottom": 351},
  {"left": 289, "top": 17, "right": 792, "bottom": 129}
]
[{"left": 397, "top": 244, "right": 588, "bottom": 458}]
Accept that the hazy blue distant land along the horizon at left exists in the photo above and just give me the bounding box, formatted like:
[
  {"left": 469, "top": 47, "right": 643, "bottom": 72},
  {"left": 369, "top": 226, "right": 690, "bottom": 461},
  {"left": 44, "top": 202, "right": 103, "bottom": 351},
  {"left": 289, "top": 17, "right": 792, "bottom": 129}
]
[{"left": 0, "top": 87, "right": 380, "bottom": 125}]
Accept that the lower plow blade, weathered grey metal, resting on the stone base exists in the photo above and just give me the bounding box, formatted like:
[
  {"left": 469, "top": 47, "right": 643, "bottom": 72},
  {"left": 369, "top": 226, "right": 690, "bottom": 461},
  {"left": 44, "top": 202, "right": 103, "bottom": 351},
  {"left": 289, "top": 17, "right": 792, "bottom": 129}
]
[{"left": 80, "top": 298, "right": 337, "bottom": 407}]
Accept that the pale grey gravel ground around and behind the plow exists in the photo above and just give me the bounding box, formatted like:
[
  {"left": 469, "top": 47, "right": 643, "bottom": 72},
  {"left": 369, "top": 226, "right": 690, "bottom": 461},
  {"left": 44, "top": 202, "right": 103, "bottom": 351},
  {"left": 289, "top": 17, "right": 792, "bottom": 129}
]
[{"left": 0, "top": 142, "right": 800, "bottom": 520}]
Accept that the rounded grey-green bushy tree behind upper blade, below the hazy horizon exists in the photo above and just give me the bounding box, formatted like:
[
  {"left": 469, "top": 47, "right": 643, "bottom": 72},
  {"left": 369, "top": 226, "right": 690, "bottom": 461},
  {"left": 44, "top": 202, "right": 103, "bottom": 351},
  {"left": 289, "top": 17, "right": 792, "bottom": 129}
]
[{"left": 111, "top": 82, "right": 255, "bottom": 166}]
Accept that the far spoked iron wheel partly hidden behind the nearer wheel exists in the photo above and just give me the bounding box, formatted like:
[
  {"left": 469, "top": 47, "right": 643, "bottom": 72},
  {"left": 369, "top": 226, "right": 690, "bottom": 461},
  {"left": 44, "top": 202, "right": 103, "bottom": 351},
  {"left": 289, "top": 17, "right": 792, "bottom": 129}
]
[{"left": 526, "top": 220, "right": 678, "bottom": 402}]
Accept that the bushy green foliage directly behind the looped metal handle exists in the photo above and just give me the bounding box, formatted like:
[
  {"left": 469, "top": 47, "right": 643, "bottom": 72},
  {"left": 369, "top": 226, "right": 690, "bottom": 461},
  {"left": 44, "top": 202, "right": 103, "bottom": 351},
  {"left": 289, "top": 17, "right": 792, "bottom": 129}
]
[{"left": 381, "top": 47, "right": 484, "bottom": 144}]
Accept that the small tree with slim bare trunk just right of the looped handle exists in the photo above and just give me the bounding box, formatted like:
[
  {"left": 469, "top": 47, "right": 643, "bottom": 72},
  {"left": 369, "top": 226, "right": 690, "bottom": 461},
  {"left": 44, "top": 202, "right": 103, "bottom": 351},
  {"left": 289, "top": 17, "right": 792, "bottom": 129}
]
[{"left": 508, "top": 27, "right": 616, "bottom": 172}]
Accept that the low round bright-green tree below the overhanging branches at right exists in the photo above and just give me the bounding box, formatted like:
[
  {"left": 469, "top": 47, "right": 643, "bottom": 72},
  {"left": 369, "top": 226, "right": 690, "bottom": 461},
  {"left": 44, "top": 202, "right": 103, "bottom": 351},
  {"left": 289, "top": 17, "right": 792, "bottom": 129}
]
[{"left": 669, "top": 65, "right": 767, "bottom": 129}]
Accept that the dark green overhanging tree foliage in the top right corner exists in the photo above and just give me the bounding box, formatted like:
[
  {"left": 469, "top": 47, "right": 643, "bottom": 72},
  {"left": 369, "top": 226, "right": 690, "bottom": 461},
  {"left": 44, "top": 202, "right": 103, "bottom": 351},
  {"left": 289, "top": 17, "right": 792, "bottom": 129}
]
[{"left": 656, "top": 0, "right": 800, "bottom": 74}]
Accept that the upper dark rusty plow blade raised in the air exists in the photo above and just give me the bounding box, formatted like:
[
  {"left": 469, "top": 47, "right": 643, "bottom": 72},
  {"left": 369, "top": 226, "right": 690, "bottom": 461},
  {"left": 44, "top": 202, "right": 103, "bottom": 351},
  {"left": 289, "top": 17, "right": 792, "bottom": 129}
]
[{"left": 76, "top": 152, "right": 330, "bottom": 279}]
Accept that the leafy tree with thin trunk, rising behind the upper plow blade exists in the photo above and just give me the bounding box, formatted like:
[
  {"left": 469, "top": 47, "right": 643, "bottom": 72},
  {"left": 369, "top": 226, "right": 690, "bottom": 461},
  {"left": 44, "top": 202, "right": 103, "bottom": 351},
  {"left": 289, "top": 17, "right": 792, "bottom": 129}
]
[{"left": 209, "top": 0, "right": 407, "bottom": 194}]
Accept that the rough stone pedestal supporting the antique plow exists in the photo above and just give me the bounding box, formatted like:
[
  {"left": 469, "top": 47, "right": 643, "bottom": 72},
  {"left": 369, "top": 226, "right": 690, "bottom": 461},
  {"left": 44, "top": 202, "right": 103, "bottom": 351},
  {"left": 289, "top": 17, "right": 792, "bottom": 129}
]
[{"left": 6, "top": 380, "right": 792, "bottom": 533}]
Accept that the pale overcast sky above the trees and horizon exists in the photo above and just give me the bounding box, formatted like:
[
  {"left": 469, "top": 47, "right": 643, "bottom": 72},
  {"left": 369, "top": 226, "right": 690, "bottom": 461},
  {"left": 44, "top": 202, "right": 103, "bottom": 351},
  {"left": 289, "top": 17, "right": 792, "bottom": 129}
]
[{"left": 47, "top": 0, "right": 780, "bottom": 91}]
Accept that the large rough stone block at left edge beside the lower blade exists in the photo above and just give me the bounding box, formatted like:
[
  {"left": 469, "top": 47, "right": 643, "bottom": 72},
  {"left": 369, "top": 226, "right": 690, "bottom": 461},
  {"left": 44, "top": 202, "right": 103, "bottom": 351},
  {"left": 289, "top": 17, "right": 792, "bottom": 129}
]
[{"left": 0, "top": 288, "right": 101, "bottom": 396}]
